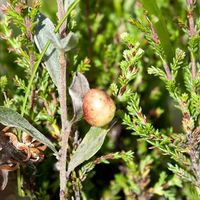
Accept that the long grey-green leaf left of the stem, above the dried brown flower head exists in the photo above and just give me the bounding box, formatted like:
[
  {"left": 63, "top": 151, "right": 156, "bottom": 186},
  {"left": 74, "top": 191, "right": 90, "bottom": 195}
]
[{"left": 0, "top": 106, "right": 57, "bottom": 154}]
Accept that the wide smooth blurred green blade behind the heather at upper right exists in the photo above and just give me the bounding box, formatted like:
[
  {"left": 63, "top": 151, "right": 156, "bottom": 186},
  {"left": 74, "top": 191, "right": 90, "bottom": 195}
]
[{"left": 142, "top": 0, "right": 174, "bottom": 62}]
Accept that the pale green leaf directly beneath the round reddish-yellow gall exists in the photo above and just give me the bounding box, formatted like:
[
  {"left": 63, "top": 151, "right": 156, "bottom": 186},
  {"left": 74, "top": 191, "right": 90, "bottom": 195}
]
[{"left": 67, "top": 127, "right": 109, "bottom": 175}]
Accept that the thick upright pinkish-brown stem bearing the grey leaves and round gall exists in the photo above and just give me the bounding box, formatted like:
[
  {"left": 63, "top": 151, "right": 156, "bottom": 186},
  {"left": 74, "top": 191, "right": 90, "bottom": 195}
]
[{"left": 55, "top": 0, "right": 79, "bottom": 200}]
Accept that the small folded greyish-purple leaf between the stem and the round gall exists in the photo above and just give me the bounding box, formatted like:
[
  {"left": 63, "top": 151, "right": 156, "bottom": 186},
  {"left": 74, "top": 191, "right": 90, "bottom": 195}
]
[{"left": 69, "top": 72, "right": 90, "bottom": 122}]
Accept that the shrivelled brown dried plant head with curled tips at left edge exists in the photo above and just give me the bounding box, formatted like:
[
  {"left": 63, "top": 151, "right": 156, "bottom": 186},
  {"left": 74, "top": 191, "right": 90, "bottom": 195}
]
[{"left": 0, "top": 127, "right": 46, "bottom": 190}]
